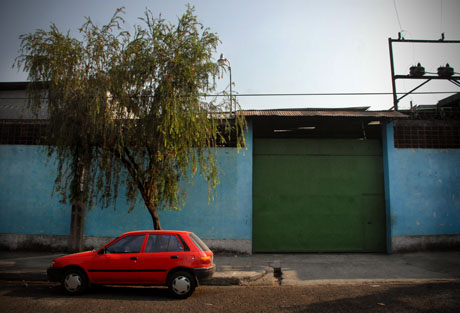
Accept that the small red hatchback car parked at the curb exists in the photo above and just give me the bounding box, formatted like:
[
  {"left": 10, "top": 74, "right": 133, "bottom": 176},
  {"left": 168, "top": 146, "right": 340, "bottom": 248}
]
[{"left": 47, "top": 231, "right": 216, "bottom": 298}]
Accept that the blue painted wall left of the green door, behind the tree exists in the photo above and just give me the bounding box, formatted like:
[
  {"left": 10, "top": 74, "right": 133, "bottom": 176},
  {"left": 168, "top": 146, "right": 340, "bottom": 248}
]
[{"left": 0, "top": 123, "right": 253, "bottom": 239}]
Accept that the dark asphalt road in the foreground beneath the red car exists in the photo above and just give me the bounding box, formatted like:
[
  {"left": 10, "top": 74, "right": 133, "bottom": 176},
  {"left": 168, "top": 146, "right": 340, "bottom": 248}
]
[{"left": 0, "top": 281, "right": 460, "bottom": 313}]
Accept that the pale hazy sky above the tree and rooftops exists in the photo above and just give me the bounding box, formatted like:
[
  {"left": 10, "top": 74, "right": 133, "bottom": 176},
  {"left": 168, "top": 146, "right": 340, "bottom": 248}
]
[{"left": 0, "top": 0, "right": 460, "bottom": 110}]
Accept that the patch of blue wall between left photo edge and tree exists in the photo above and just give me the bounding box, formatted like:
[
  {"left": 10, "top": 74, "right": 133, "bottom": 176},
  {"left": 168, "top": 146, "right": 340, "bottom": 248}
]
[{"left": 0, "top": 145, "right": 70, "bottom": 235}]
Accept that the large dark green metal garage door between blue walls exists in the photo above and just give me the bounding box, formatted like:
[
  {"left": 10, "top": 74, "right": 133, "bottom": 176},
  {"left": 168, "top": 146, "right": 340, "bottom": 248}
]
[{"left": 253, "top": 139, "right": 385, "bottom": 252}]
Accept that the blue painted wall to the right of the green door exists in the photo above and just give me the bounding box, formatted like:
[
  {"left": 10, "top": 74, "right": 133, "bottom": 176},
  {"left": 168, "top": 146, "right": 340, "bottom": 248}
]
[{"left": 383, "top": 123, "right": 460, "bottom": 237}]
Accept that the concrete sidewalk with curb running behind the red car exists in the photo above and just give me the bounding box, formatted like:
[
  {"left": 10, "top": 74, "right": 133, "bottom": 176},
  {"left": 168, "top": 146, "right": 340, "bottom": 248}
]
[{"left": 0, "top": 251, "right": 460, "bottom": 285}]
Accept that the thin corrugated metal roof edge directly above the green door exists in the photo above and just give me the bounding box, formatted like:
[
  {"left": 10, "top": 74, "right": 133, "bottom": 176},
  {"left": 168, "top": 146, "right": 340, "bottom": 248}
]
[{"left": 242, "top": 109, "right": 407, "bottom": 118}]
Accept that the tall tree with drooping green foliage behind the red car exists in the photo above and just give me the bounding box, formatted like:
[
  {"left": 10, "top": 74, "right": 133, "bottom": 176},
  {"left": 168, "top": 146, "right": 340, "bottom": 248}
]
[{"left": 15, "top": 6, "right": 245, "bottom": 250}]
